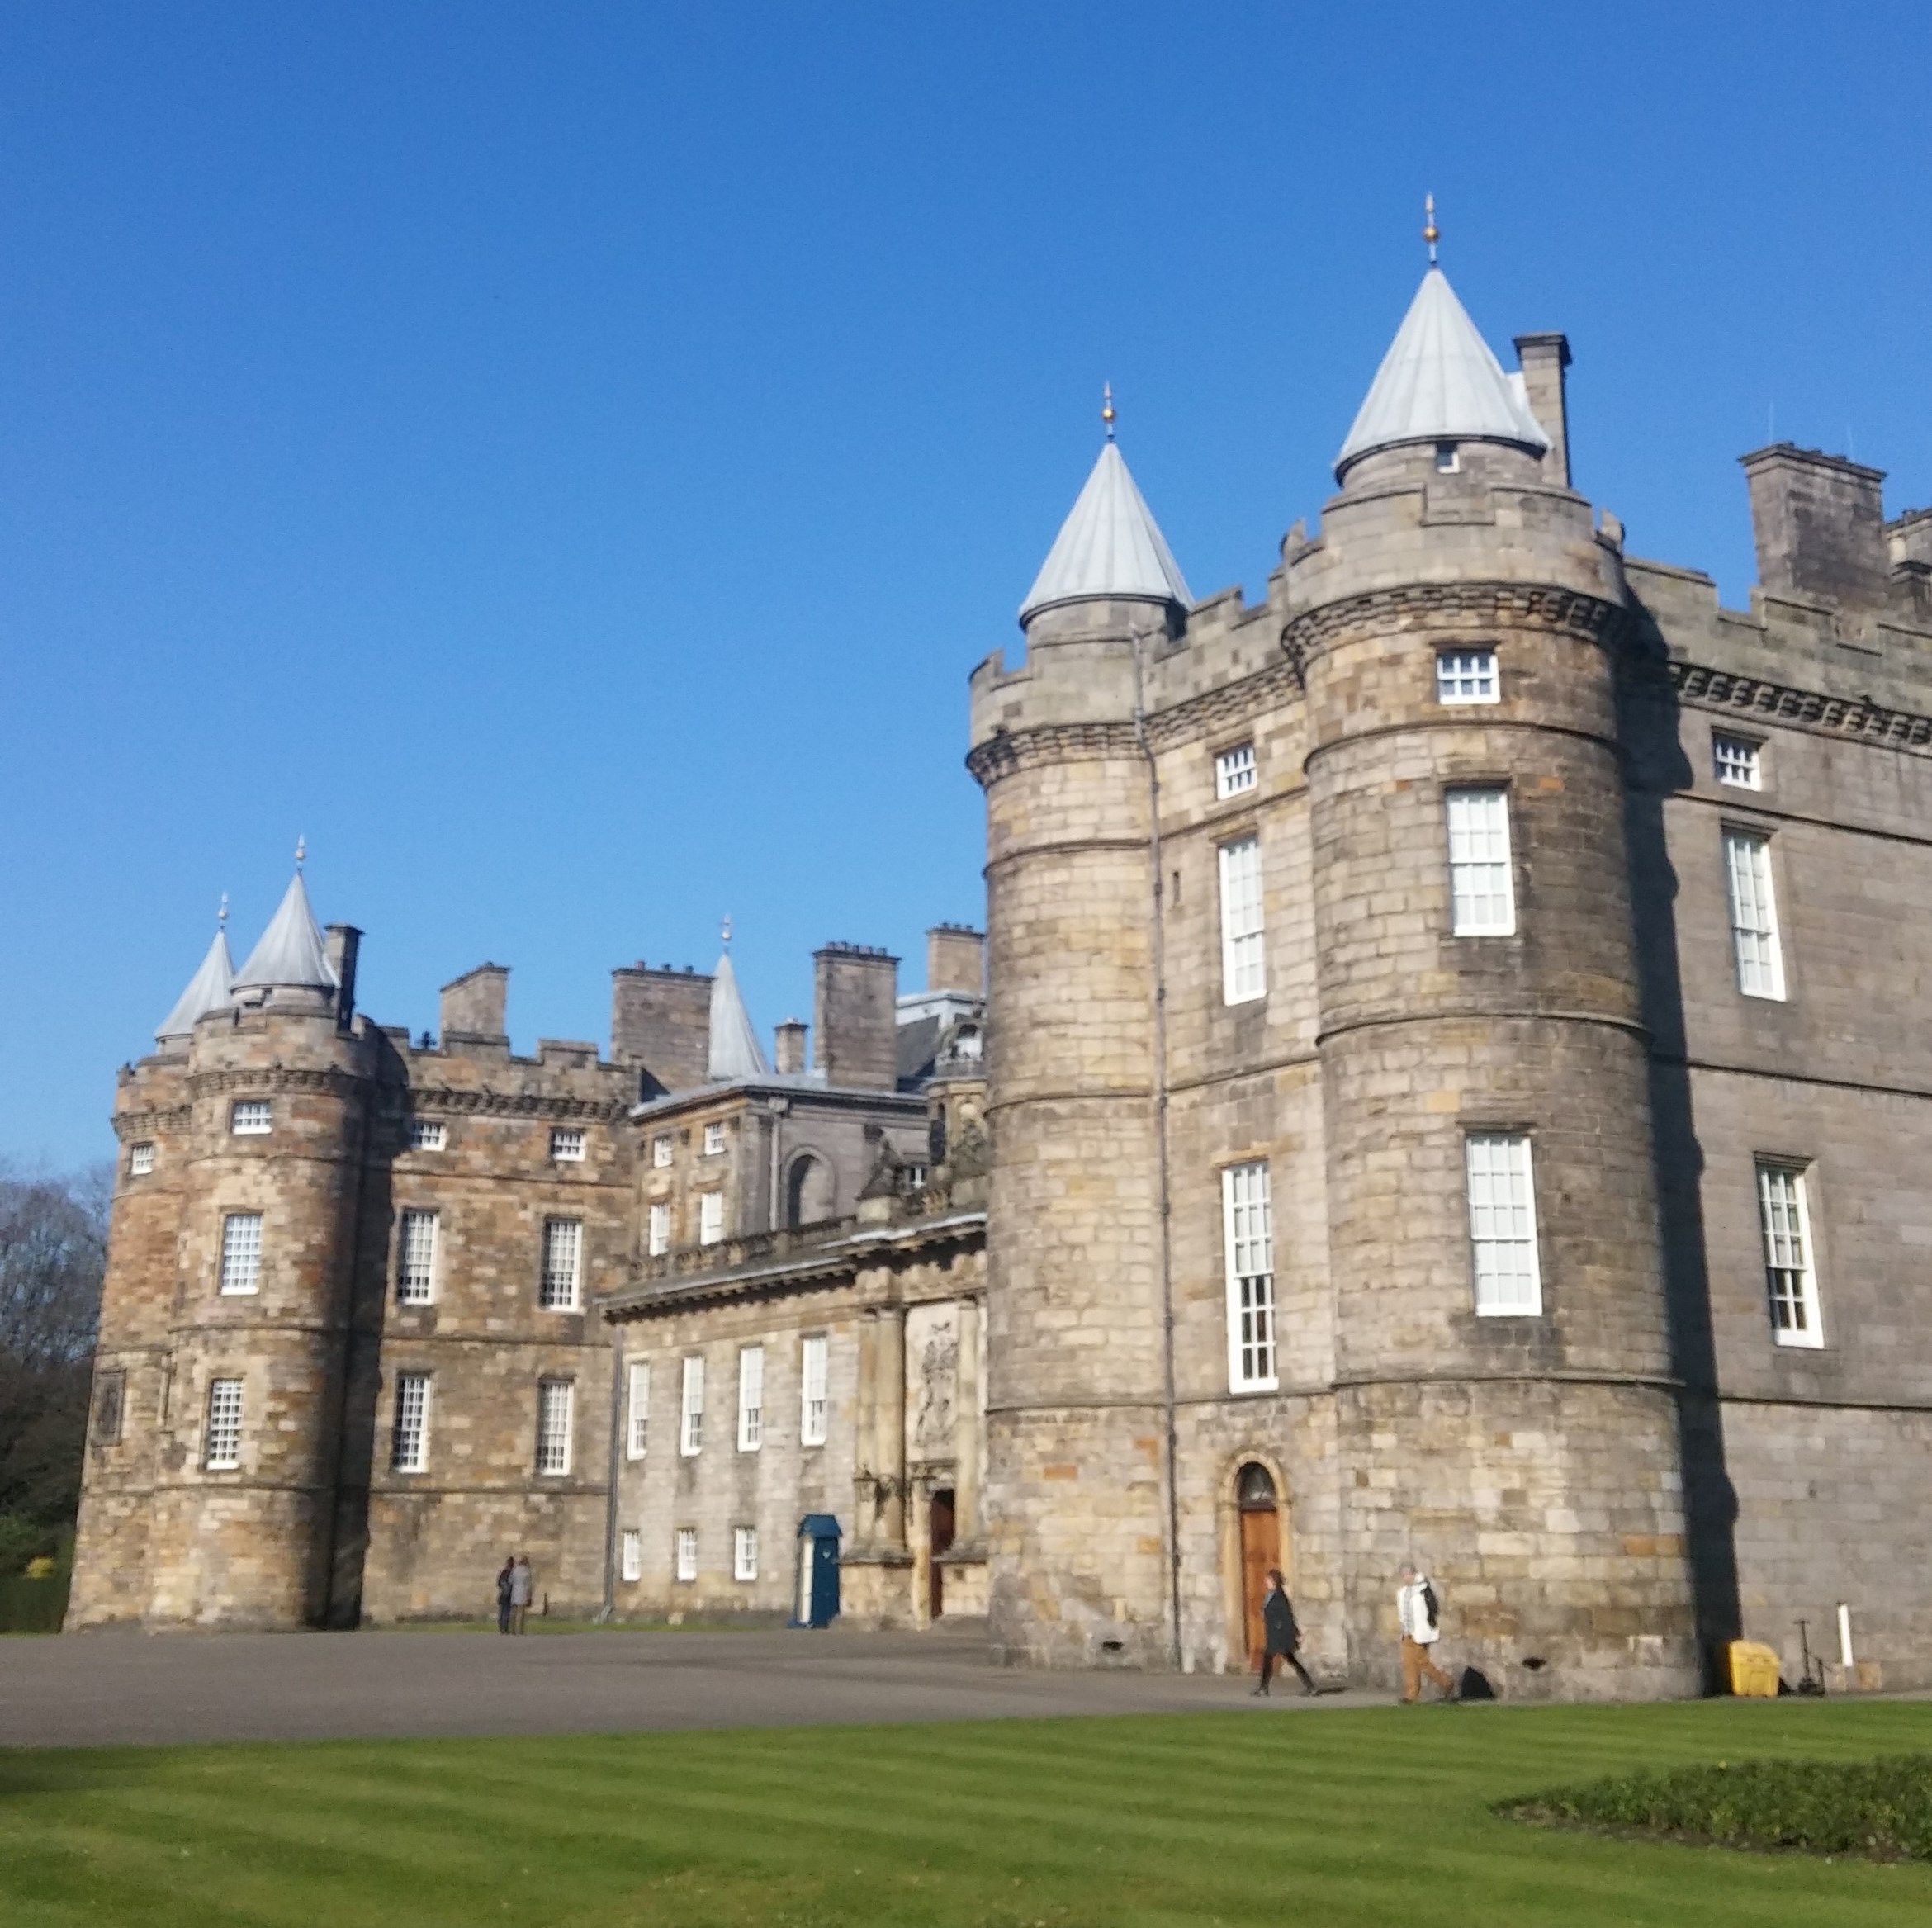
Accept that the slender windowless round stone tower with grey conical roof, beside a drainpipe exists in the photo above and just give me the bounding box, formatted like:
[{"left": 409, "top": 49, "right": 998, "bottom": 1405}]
[{"left": 968, "top": 433, "right": 1188, "bottom": 1665}]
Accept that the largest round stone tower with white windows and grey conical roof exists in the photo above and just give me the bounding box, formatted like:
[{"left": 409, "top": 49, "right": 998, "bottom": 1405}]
[{"left": 1283, "top": 267, "right": 1698, "bottom": 1698}]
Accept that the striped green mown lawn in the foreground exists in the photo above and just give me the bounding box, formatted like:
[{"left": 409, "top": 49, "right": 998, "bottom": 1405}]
[{"left": 0, "top": 1702, "right": 1932, "bottom": 1928}]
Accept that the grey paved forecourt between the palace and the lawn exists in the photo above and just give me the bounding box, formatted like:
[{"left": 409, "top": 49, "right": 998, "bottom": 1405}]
[{"left": 0, "top": 1627, "right": 1385, "bottom": 1746}]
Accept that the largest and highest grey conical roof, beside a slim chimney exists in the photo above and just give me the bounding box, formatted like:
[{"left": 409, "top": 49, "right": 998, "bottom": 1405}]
[{"left": 1335, "top": 267, "right": 1550, "bottom": 481}]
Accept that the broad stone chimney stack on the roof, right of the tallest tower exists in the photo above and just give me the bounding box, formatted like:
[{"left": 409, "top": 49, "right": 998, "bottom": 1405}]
[{"left": 1739, "top": 443, "right": 1892, "bottom": 610}]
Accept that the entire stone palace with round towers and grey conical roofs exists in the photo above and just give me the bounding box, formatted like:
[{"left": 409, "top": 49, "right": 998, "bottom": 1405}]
[{"left": 69, "top": 241, "right": 1932, "bottom": 1698}]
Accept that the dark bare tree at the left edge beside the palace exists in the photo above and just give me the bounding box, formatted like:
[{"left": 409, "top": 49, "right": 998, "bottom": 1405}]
[{"left": 0, "top": 1169, "right": 112, "bottom": 1543}]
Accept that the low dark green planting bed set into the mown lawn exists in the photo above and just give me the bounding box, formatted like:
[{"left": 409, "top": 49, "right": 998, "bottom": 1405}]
[{"left": 1495, "top": 1754, "right": 1932, "bottom": 1860}]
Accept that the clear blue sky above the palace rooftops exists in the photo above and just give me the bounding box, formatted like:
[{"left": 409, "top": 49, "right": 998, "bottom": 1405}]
[{"left": 0, "top": 0, "right": 1932, "bottom": 1165}]
